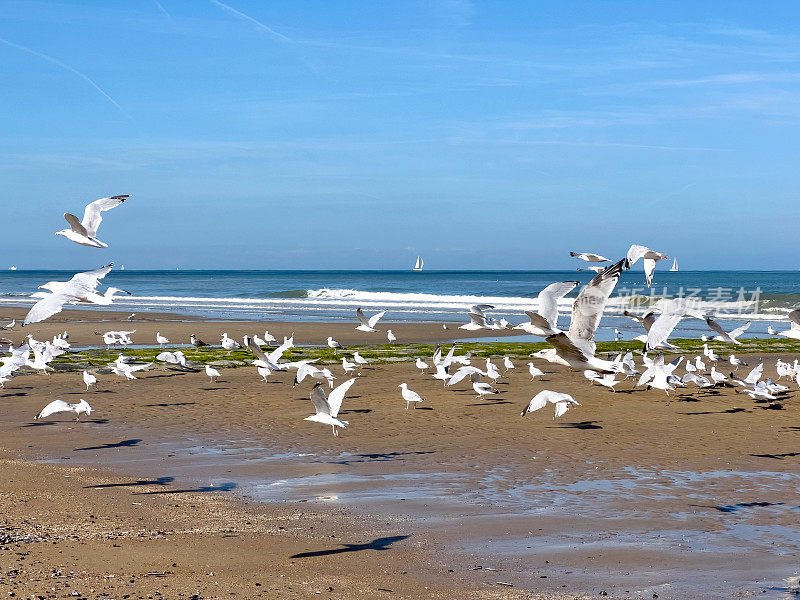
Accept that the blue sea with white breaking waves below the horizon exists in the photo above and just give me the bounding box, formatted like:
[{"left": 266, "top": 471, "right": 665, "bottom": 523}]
[{"left": 0, "top": 265, "right": 800, "bottom": 340}]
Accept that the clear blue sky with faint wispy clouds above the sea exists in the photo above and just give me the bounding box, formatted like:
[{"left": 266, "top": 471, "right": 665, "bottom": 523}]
[{"left": 0, "top": 0, "right": 800, "bottom": 269}]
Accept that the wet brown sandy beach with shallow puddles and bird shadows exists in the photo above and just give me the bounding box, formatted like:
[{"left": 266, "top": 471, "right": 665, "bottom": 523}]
[{"left": 0, "top": 312, "right": 800, "bottom": 598}]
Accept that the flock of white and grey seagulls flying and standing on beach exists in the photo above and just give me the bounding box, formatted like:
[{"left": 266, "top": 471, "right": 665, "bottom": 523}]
[{"left": 0, "top": 209, "right": 800, "bottom": 428}]
